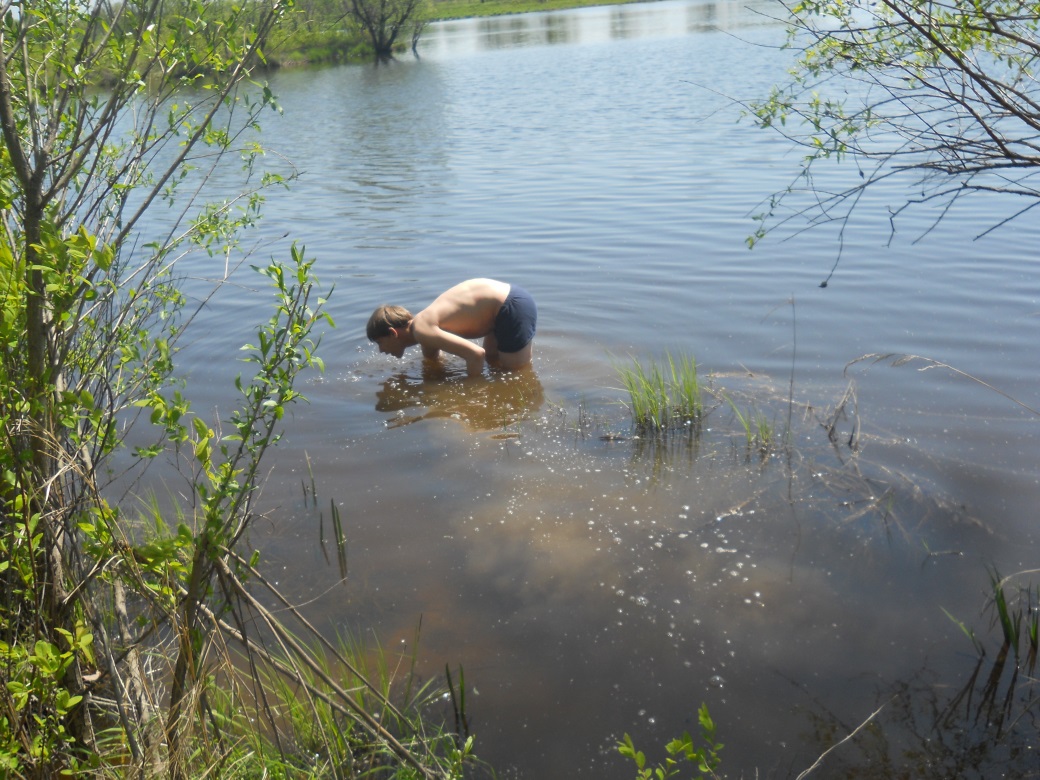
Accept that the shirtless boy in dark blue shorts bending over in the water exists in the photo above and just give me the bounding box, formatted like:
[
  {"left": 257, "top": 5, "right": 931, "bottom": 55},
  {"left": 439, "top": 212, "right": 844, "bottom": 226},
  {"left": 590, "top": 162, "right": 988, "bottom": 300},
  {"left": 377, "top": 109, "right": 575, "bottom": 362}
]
[{"left": 367, "top": 279, "right": 538, "bottom": 376}]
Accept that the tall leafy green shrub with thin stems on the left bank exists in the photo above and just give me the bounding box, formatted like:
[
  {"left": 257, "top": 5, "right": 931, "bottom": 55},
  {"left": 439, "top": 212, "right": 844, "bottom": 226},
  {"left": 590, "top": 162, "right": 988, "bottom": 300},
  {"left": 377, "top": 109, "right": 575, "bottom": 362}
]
[{"left": 0, "top": 0, "right": 463, "bottom": 778}]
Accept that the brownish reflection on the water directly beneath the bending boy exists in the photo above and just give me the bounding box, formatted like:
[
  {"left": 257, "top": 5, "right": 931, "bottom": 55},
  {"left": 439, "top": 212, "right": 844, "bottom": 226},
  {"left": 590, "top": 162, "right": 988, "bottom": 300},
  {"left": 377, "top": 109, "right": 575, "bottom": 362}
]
[{"left": 375, "top": 363, "right": 545, "bottom": 431}]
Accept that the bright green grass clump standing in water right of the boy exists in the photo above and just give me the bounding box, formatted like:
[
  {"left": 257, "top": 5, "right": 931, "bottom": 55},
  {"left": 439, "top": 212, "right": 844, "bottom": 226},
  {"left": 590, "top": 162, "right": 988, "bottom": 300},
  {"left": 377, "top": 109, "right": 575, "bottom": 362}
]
[{"left": 618, "top": 354, "right": 704, "bottom": 434}]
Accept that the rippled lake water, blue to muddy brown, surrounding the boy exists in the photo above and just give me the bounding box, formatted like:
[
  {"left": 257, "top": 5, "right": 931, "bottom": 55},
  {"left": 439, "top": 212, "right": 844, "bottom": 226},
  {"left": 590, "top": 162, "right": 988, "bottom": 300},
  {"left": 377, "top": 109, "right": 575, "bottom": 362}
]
[{"left": 158, "top": 0, "right": 1040, "bottom": 780}]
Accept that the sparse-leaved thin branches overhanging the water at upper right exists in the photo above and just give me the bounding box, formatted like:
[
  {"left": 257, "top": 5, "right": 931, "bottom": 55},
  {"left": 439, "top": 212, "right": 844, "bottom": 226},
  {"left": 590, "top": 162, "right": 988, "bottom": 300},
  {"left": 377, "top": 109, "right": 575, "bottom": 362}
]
[{"left": 751, "top": 0, "right": 1040, "bottom": 263}]
